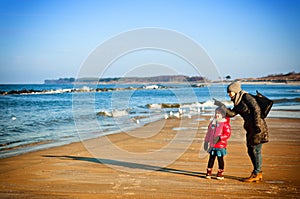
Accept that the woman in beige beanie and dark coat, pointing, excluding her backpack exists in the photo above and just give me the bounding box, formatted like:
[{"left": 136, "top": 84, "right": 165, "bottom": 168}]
[{"left": 215, "top": 81, "right": 268, "bottom": 182}]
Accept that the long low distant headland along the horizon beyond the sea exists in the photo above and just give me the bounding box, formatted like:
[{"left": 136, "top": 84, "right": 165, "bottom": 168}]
[{"left": 44, "top": 72, "right": 300, "bottom": 84}]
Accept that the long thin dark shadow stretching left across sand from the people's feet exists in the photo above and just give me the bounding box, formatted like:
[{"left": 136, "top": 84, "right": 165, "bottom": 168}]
[{"left": 43, "top": 155, "right": 242, "bottom": 181}]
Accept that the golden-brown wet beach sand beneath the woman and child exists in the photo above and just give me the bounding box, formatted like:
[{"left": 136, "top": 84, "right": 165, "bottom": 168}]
[{"left": 0, "top": 116, "right": 300, "bottom": 199}]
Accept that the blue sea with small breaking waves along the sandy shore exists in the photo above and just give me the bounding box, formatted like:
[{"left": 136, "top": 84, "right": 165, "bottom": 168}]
[{"left": 0, "top": 84, "right": 300, "bottom": 158}]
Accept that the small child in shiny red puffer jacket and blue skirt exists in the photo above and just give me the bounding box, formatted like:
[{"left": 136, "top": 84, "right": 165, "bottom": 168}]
[{"left": 204, "top": 107, "right": 231, "bottom": 180}]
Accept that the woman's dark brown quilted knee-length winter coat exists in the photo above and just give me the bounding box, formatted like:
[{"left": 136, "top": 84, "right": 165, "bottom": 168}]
[{"left": 225, "top": 93, "right": 269, "bottom": 146}]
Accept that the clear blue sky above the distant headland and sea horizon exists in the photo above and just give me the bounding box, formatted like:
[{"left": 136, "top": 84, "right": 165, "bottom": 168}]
[{"left": 0, "top": 0, "right": 300, "bottom": 84}]
